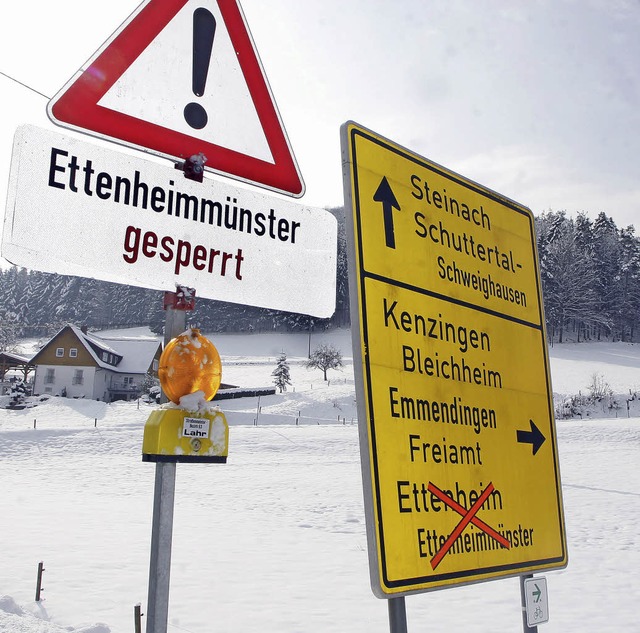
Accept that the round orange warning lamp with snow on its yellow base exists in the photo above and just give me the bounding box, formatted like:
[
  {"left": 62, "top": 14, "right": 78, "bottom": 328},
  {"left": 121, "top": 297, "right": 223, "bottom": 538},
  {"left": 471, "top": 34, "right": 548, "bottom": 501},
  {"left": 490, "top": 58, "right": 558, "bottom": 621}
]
[{"left": 158, "top": 328, "right": 222, "bottom": 404}]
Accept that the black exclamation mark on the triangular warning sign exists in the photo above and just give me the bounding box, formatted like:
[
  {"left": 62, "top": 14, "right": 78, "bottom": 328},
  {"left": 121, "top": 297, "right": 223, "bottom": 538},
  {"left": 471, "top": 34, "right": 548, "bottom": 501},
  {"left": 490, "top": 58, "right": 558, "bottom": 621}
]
[{"left": 184, "top": 8, "right": 216, "bottom": 130}]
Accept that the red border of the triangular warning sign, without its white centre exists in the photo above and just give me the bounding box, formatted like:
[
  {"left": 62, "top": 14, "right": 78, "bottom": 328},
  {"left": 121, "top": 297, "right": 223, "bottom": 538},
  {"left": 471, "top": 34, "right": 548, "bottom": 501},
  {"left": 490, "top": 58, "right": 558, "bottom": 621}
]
[{"left": 47, "top": 0, "right": 305, "bottom": 198}]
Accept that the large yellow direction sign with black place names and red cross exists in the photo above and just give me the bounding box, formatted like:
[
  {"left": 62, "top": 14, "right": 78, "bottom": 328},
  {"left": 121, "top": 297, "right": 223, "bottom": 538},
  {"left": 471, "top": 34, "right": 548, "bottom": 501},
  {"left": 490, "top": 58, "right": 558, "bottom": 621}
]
[{"left": 342, "top": 123, "right": 567, "bottom": 597}]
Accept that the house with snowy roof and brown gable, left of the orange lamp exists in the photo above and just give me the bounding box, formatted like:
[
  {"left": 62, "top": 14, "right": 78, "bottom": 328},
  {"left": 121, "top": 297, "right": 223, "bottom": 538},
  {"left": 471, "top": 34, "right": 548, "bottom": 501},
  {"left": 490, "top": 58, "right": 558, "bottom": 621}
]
[{"left": 30, "top": 325, "right": 162, "bottom": 402}]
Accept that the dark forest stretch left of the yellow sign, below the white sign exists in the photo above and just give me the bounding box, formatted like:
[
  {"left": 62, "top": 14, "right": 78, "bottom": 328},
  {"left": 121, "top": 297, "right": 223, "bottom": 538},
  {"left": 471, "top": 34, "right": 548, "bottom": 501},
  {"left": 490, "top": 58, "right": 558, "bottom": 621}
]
[{"left": 0, "top": 208, "right": 349, "bottom": 340}]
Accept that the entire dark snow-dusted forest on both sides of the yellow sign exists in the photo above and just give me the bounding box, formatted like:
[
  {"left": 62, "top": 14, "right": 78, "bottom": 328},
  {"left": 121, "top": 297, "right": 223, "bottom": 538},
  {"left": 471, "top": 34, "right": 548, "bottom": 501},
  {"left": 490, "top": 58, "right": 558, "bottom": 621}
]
[{"left": 0, "top": 208, "right": 640, "bottom": 349}]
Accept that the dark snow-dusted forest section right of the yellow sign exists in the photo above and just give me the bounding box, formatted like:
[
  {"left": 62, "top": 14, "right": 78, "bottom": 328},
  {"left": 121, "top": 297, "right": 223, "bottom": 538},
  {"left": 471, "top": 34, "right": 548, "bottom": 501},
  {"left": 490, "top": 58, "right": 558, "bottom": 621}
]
[{"left": 536, "top": 211, "right": 640, "bottom": 343}]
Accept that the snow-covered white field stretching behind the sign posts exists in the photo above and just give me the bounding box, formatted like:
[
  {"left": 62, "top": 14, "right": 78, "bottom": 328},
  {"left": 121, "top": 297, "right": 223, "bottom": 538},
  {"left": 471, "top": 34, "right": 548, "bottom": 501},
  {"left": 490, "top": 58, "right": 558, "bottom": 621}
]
[{"left": 0, "top": 331, "right": 640, "bottom": 633}]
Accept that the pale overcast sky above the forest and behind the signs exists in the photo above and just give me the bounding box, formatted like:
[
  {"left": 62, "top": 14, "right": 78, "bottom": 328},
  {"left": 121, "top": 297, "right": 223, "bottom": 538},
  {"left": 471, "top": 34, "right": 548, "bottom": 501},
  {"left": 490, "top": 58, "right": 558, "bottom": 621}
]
[{"left": 0, "top": 0, "right": 640, "bottom": 266}]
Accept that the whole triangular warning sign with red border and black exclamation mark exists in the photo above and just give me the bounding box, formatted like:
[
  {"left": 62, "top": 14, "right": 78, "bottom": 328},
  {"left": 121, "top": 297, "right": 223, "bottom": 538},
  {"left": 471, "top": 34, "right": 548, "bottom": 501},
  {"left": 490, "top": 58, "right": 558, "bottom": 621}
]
[{"left": 48, "top": 0, "right": 304, "bottom": 197}]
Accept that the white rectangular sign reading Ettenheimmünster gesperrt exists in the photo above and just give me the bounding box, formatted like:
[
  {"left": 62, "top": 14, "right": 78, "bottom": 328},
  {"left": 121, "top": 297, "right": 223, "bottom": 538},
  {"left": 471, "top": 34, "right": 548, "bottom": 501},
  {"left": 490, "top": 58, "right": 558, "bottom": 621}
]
[{"left": 2, "top": 126, "right": 337, "bottom": 318}]
